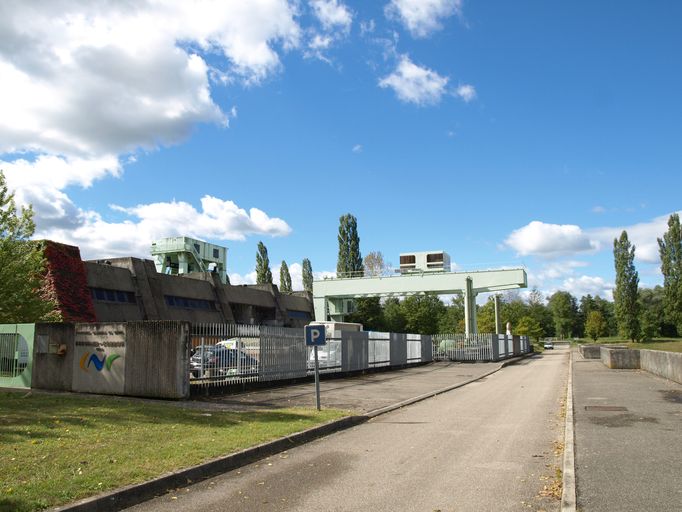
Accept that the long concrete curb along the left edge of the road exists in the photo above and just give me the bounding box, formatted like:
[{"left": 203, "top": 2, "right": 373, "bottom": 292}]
[{"left": 50, "top": 353, "right": 534, "bottom": 512}]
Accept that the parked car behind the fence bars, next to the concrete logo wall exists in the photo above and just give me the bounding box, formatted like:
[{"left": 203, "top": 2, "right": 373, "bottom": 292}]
[{"left": 189, "top": 345, "right": 258, "bottom": 377}]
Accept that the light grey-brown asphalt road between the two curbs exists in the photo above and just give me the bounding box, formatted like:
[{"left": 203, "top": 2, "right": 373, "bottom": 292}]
[{"left": 129, "top": 348, "right": 568, "bottom": 512}]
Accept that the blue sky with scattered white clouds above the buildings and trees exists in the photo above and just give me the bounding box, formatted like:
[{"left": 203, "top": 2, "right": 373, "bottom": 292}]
[{"left": 0, "top": 0, "right": 682, "bottom": 297}]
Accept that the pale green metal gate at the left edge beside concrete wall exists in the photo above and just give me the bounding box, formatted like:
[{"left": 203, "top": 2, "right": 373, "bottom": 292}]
[{"left": 0, "top": 324, "right": 36, "bottom": 388}]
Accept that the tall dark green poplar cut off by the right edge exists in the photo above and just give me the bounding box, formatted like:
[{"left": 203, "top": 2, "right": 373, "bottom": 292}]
[{"left": 658, "top": 213, "right": 682, "bottom": 334}]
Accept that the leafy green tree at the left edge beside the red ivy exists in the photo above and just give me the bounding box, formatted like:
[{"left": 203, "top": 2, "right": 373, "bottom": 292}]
[{"left": 0, "top": 171, "right": 60, "bottom": 324}]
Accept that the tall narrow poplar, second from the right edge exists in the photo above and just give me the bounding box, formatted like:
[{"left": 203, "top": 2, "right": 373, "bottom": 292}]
[{"left": 613, "top": 231, "right": 640, "bottom": 341}]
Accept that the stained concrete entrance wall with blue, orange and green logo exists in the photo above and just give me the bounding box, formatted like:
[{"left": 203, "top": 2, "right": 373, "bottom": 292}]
[{"left": 31, "top": 321, "right": 190, "bottom": 398}]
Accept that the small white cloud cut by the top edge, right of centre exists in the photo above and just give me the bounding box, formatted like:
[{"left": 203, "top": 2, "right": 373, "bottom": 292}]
[{"left": 385, "top": 0, "right": 462, "bottom": 37}]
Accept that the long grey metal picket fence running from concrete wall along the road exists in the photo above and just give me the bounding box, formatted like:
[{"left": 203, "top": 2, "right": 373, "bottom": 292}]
[{"left": 188, "top": 324, "right": 529, "bottom": 390}]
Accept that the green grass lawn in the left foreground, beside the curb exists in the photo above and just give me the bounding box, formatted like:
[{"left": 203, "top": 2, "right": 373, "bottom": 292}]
[{"left": 0, "top": 392, "right": 347, "bottom": 512}]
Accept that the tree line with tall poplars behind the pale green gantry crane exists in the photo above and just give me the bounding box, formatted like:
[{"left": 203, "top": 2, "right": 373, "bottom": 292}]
[{"left": 337, "top": 214, "right": 682, "bottom": 341}]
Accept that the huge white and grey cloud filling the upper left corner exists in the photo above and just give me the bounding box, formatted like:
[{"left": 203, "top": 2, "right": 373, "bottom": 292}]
[{"left": 0, "top": 0, "right": 300, "bottom": 157}]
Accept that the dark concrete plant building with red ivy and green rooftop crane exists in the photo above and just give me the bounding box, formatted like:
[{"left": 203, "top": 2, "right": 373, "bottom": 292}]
[{"left": 43, "top": 237, "right": 313, "bottom": 327}]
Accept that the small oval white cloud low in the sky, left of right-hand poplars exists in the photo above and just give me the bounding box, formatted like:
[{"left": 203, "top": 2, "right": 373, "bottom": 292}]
[{"left": 504, "top": 220, "right": 598, "bottom": 257}]
